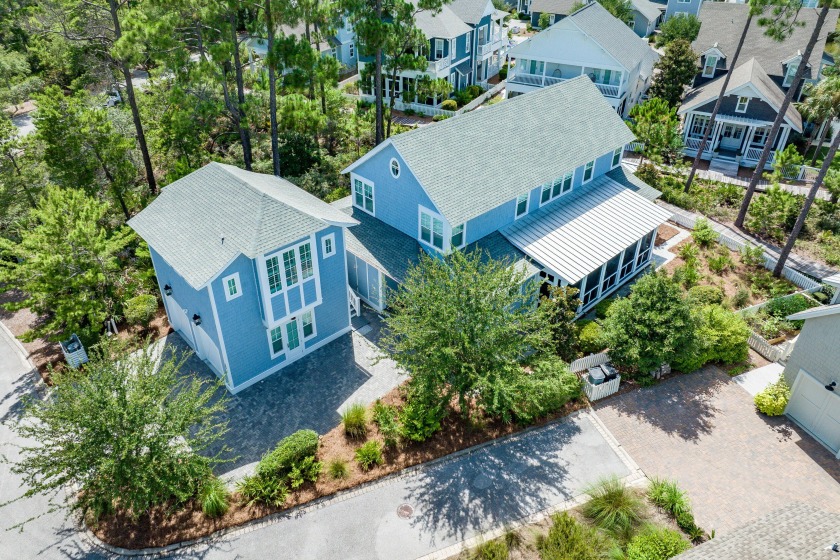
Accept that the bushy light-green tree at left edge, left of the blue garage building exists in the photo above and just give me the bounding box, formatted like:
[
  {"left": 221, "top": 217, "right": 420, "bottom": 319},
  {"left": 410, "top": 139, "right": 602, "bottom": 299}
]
[{"left": 0, "top": 186, "right": 132, "bottom": 342}]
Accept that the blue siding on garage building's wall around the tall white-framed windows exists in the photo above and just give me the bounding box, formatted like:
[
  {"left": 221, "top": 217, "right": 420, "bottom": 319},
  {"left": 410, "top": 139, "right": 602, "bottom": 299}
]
[{"left": 212, "top": 226, "right": 350, "bottom": 390}]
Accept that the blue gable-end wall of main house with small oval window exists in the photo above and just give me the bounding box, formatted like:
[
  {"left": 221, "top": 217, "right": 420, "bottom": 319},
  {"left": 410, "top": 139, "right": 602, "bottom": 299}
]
[{"left": 350, "top": 145, "right": 440, "bottom": 245}]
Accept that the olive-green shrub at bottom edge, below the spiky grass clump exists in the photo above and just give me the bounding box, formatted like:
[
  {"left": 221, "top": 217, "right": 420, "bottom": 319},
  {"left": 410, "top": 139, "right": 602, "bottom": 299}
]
[{"left": 536, "top": 511, "right": 615, "bottom": 560}]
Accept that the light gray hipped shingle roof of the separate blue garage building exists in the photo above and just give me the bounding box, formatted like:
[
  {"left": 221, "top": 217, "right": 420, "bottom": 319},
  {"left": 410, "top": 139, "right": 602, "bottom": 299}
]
[{"left": 128, "top": 163, "right": 357, "bottom": 289}]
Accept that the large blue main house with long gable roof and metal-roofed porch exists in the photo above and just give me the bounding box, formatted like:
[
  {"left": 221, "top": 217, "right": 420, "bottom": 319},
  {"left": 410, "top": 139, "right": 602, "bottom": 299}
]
[{"left": 334, "top": 77, "right": 670, "bottom": 311}]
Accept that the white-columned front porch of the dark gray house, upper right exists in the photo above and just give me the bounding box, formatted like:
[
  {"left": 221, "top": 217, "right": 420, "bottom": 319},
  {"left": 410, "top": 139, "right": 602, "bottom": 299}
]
[{"left": 683, "top": 112, "right": 792, "bottom": 169}]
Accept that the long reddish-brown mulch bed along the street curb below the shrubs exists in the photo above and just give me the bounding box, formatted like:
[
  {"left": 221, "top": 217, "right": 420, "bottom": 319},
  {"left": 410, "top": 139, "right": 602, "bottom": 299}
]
[{"left": 91, "top": 388, "right": 587, "bottom": 549}]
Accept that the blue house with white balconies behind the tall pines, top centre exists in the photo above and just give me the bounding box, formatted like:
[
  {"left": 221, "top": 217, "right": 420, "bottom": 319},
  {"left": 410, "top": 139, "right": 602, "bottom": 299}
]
[{"left": 359, "top": 0, "right": 508, "bottom": 106}]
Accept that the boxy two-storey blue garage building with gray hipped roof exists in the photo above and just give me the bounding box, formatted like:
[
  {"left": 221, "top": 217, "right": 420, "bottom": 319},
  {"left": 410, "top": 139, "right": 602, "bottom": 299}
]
[{"left": 129, "top": 163, "right": 357, "bottom": 393}]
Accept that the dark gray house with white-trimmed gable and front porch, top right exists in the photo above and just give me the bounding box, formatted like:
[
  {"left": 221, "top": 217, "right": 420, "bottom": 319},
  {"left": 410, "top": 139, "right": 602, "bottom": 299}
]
[{"left": 678, "top": 2, "right": 838, "bottom": 170}]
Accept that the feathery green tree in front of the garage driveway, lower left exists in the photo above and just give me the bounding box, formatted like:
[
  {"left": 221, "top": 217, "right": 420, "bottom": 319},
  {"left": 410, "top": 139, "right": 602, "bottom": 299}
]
[{"left": 13, "top": 339, "right": 227, "bottom": 519}]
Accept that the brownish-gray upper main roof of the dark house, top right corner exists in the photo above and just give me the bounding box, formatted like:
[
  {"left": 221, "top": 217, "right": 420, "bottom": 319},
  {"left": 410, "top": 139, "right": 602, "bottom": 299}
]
[{"left": 692, "top": 2, "right": 840, "bottom": 81}]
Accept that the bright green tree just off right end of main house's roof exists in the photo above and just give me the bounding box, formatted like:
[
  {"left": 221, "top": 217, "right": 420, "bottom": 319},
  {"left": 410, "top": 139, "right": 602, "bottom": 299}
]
[{"left": 629, "top": 97, "right": 682, "bottom": 162}]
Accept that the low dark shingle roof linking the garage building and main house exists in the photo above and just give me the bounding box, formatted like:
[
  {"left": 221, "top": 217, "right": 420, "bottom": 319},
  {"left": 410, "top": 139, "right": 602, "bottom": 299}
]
[{"left": 332, "top": 196, "right": 422, "bottom": 282}]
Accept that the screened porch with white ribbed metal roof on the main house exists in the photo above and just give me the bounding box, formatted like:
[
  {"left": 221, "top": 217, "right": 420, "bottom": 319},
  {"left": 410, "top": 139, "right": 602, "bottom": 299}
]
[{"left": 502, "top": 174, "right": 671, "bottom": 314}]
